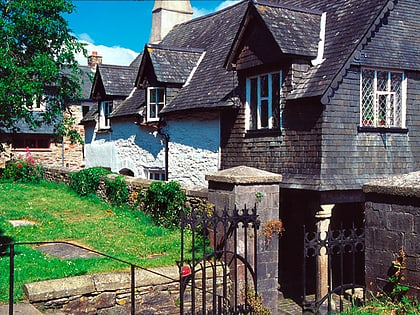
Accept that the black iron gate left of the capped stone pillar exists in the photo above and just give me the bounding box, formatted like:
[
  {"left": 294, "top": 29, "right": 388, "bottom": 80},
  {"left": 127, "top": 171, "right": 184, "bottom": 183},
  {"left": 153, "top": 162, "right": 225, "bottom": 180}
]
[{"left": 178, "top": 208, "right": 259, "bottom": 315}]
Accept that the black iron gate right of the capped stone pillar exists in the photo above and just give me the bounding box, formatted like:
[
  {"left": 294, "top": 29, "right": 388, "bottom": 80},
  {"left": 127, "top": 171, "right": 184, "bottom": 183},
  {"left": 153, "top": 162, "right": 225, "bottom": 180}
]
[{"left": 302, "top": 224, "right": 365, "bottom": 314}]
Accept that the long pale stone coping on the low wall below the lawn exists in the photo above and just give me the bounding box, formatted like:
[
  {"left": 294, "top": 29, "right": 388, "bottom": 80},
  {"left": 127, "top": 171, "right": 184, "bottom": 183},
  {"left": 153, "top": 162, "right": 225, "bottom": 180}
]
[{"left": 23, "top": 266, "right": 179, "bottom": 303}]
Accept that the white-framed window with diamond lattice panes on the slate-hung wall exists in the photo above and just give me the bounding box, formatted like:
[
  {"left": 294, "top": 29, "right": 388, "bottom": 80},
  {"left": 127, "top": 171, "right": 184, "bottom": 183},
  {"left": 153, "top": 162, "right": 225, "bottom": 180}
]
[{"left": 360, "top": 68, "right": 407, "bottom": 128}]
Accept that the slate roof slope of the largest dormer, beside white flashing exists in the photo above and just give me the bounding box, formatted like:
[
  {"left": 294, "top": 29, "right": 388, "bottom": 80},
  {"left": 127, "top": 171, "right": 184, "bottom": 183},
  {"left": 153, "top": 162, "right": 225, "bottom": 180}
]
[{"left": 255, "top": 1, "right": 322, "bottom": 57}]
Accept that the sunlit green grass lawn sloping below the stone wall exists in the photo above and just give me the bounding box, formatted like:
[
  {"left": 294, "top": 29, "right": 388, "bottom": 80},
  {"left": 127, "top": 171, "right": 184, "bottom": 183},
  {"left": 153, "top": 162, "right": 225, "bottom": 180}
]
[{"left": 0, "top": 182, "right": 181, "bottom": 302}]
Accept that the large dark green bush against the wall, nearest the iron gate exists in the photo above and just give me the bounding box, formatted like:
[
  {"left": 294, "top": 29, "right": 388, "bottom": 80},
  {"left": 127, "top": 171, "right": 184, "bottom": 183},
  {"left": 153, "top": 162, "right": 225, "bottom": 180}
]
[{"left": 143, "top": 181, "right": 186, "bottom": 228}]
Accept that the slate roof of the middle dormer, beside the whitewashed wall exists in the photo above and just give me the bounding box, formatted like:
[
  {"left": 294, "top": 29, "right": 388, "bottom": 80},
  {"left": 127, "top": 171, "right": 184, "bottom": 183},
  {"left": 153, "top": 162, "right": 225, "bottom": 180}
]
[{"left": 137, "top": 44, "right": 203, "bottom": 84}]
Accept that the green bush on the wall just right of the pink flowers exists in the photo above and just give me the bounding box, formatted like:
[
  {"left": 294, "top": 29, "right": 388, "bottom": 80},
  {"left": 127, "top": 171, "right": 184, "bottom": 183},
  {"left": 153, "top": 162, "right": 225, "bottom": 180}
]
[{"left": 70, "top": 167, "right": 111, "bottom": 196}]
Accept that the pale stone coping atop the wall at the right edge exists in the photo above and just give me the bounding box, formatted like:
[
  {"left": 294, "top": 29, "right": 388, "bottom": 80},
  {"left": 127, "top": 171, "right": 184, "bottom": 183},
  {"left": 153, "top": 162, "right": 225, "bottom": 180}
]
[{"left": 363, "top": 171, "right": 420, "bottom": 197}]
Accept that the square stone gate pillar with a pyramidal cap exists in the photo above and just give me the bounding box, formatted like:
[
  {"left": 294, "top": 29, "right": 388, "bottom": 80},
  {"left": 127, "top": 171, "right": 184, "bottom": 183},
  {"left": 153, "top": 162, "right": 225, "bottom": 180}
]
[{"left": 206, "top": 166, "right": 282, "bottom": 314}]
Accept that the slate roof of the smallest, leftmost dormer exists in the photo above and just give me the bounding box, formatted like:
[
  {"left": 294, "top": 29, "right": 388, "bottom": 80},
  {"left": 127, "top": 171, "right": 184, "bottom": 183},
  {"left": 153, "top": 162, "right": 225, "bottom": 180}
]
[{"left": 92, "top": 64, "right": 137, "bottom": 96}]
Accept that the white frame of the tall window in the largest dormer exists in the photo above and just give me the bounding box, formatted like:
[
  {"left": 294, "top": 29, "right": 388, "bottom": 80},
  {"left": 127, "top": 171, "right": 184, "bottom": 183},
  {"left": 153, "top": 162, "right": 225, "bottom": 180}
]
[{"left": 245, "top": 70, "right": 283, "bottom": 132}]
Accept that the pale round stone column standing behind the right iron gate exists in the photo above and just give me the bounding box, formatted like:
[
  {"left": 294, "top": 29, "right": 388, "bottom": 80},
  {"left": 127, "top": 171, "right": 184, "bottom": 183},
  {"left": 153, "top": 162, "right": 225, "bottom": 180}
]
[{"left": 315, "top": 204, "right": 334, "bottom": 300}]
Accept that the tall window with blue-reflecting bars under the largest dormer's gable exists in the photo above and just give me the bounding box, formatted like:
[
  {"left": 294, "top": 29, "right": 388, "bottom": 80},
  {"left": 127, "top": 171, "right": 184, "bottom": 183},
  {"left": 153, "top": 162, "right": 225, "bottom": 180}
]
[{"left": 246, "top": 72, "right": 282, "bottom": 130}]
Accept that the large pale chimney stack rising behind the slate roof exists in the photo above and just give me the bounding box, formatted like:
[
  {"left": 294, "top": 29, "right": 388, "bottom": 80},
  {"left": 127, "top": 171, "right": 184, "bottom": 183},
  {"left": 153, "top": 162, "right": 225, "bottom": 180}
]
[{"left": 150, "top": 0, "right": 193, "bottom": 44}]
